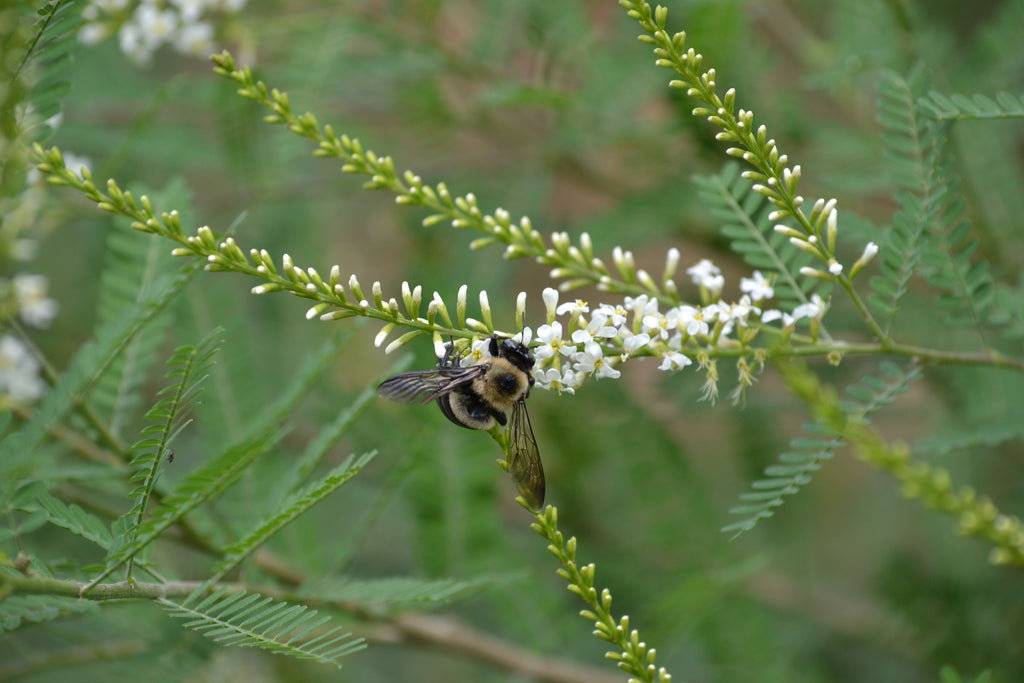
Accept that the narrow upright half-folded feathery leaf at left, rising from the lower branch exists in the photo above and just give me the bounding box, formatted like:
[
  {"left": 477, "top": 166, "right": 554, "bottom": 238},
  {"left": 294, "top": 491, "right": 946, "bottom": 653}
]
[{"left": 117, "top": 328, "right": 223, "bottom": 577}]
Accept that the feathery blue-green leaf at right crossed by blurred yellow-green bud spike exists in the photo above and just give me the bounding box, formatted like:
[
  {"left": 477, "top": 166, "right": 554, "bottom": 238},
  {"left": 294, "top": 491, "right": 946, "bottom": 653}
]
[{"left": 722, "top": 361, "right": 921, "bottom": 538}]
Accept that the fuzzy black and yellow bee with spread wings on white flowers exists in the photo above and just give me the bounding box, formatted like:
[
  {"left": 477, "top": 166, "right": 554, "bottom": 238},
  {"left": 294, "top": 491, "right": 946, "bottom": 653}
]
[{"left": 377, "top": 335, "right": 544, "bottom": 510}]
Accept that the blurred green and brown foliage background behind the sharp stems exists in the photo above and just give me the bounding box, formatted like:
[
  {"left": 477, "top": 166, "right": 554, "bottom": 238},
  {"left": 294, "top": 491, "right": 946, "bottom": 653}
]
[{"left": 8, "top": 0, "right": 1024, "bottom": 683}]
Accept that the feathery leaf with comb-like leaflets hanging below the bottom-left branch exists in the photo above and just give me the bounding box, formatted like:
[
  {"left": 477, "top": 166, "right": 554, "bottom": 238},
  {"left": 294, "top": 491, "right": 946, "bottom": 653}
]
[{"left": 158, "top": 589, "right": 366, "bottom": 667}]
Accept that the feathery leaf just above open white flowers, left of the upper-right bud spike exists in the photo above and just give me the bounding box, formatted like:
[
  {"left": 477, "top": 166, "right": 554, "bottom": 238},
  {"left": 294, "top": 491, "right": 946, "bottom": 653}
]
[{"left": 693, "top": 162, "right": 825, "bottom": 308}]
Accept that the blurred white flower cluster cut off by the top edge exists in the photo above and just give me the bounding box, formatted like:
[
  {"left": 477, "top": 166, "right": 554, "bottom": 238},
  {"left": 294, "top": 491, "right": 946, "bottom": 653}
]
[{"left": 79, "top": 0, "right": 246, "bottom": 65}]
